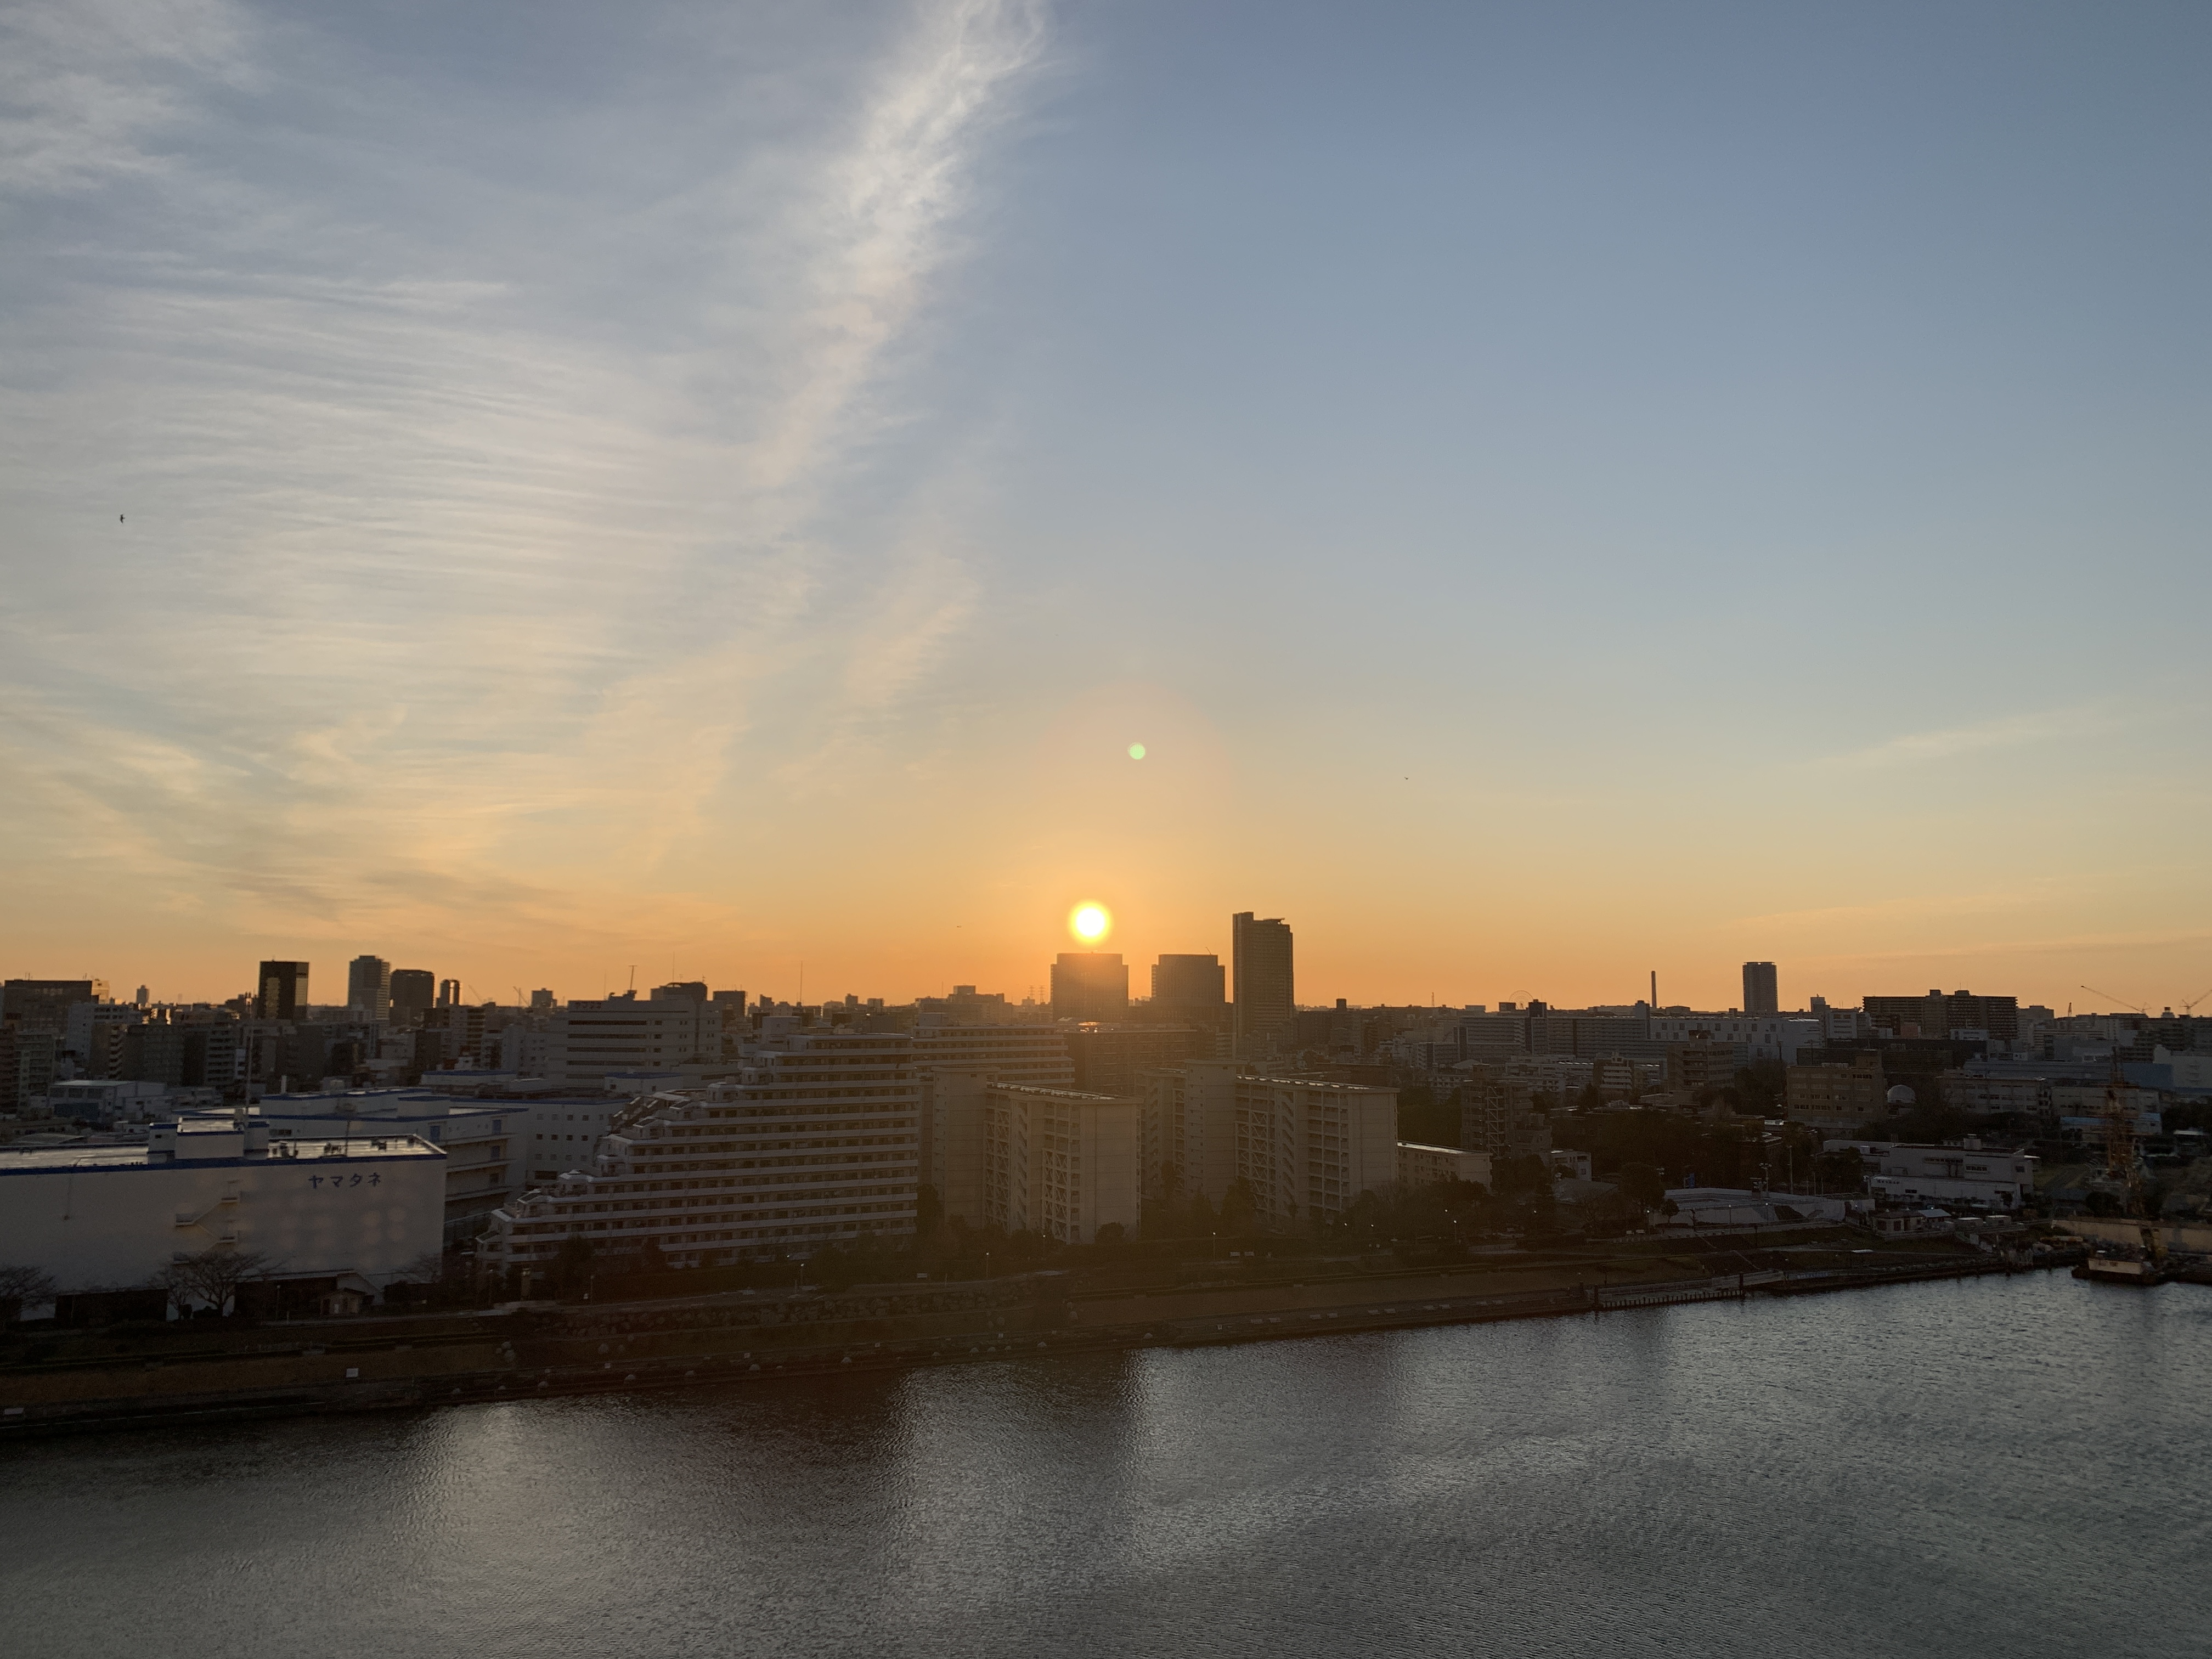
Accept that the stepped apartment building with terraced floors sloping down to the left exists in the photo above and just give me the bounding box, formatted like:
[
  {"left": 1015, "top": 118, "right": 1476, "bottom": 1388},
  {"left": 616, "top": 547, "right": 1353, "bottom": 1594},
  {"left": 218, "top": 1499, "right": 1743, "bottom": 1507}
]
[{"left": 480, "top": 1033, "right": 920, "bottom": 1267}]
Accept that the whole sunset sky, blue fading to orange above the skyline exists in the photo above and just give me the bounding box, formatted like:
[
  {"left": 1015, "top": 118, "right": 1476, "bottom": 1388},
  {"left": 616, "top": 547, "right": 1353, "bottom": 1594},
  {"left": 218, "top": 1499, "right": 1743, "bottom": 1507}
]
[{"left": 0, "top": 0, "right": 2212, "bottom": 1009}]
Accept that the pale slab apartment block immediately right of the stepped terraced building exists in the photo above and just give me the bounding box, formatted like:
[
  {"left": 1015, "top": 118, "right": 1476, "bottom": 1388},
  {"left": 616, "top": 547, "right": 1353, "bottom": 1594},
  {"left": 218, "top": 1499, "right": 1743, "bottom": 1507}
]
[{"left": 927, "top": 1073, "right": 1144, "bottom": 1243}]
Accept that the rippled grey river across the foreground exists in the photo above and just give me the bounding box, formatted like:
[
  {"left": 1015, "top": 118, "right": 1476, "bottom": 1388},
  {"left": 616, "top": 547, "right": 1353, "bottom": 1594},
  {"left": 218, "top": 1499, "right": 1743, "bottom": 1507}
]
[{"left": 0, "top": 1274, "right": 2212, "bottom": 1659}]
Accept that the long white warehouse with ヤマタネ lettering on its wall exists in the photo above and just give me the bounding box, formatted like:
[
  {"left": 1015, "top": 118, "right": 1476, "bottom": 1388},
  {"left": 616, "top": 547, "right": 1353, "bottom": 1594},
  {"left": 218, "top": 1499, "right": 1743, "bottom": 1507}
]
[{"left": 0, "top": 1117, "right": 444, "bottom": 1294}]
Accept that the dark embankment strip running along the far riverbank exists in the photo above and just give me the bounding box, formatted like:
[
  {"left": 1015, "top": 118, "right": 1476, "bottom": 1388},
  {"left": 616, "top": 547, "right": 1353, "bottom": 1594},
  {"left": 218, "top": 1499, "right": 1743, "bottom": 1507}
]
[{"left": 0, "top": 1256, "right": 2061, "bottom": 1440}]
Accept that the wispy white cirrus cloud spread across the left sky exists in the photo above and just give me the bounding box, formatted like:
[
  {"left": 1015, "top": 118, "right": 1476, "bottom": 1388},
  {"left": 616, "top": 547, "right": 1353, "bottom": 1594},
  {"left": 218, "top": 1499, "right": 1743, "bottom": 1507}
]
[{"left": 0, "top": 0, "right": 1044, "bottom": 960}]
